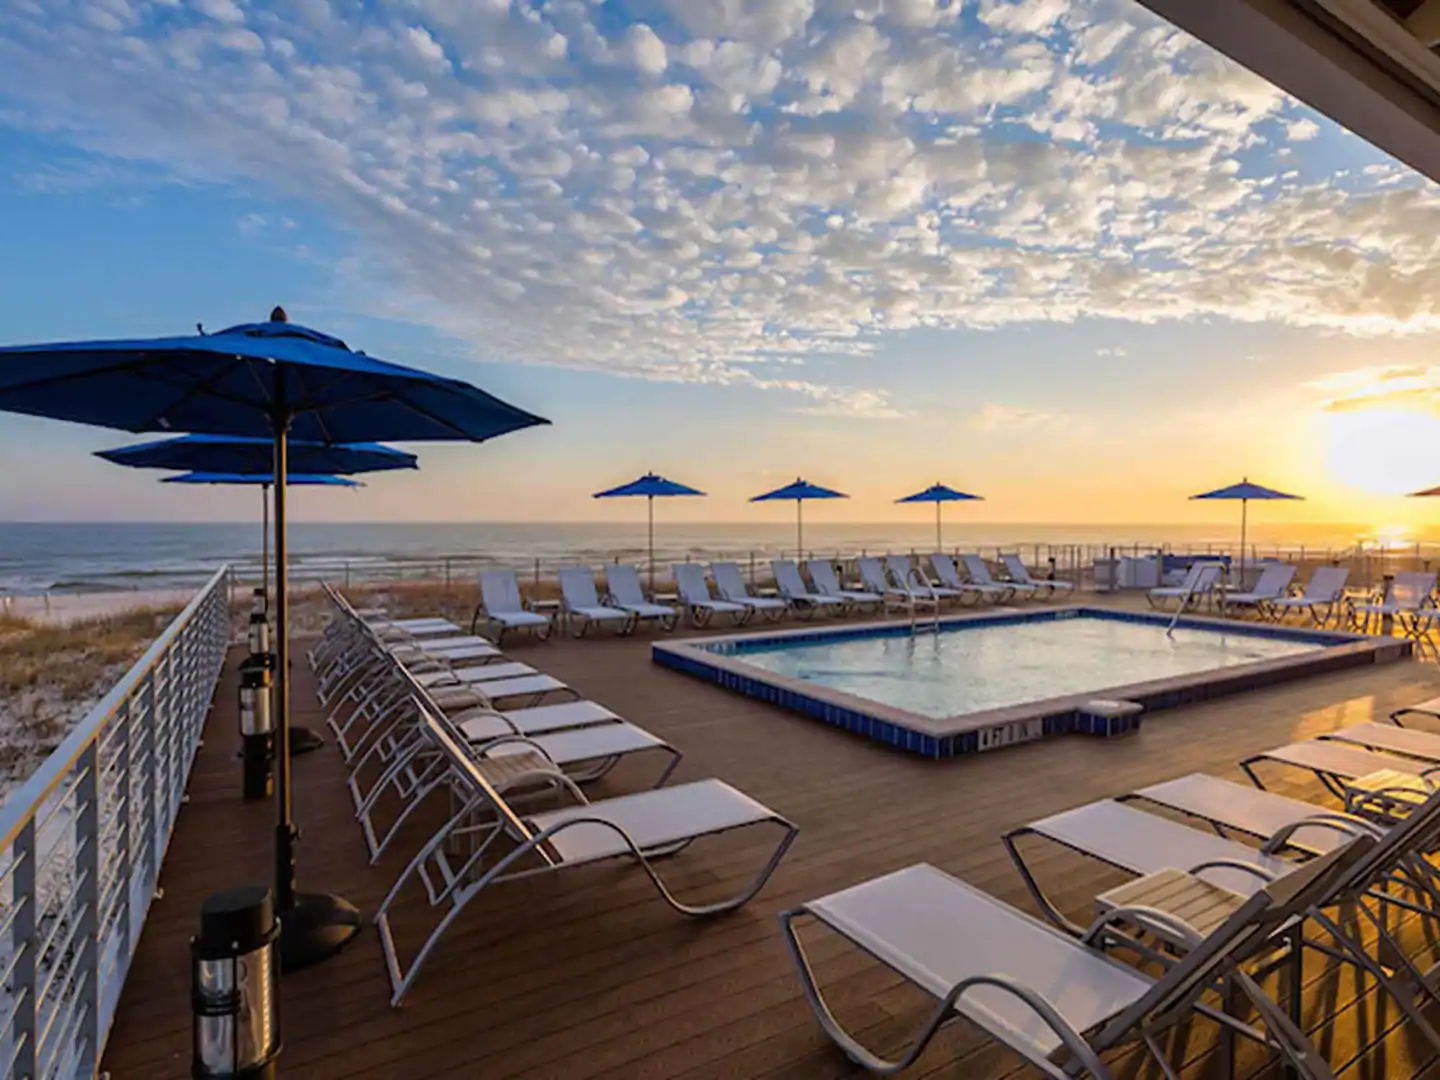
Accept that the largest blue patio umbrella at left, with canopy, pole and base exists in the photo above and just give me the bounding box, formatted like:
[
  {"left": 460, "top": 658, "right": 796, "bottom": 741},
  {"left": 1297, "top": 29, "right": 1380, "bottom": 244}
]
[{"left": 0, "top": 308, "right": 547, "bottom": 971}]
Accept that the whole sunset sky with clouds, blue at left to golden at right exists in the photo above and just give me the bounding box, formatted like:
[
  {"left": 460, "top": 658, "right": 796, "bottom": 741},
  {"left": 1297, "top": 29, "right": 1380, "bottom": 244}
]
[{"left": 0, "top": 0, "right": 1440, "bottom": 524}]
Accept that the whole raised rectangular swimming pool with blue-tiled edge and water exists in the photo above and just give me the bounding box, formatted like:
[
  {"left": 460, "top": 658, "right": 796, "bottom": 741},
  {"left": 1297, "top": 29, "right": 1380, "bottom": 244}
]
[{"left": 652, "top": 606, "right": 1410, "bottom": 757}]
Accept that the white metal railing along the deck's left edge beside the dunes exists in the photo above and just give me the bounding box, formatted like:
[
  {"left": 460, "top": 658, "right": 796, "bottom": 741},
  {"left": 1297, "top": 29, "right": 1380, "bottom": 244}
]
[{"left": 0, "top": 567, "right": 230, "bottom": 1080}]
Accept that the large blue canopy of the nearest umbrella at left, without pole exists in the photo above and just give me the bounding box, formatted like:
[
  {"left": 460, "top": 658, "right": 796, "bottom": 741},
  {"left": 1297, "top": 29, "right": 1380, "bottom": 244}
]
[{"left": 0, "top": 321, "right": 549, "bottom": 444}]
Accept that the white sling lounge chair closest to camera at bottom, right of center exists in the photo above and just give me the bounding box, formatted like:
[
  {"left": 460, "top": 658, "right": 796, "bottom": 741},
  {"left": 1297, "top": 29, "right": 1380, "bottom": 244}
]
[{"left": 780, "top": 841, "right": 1369, "bottom": 1080}]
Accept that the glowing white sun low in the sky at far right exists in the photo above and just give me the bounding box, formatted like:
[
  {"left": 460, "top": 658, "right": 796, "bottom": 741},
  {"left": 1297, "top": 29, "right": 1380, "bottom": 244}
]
[{"left": 1325, "top": 409, "right": 1440, "bottom": 495}]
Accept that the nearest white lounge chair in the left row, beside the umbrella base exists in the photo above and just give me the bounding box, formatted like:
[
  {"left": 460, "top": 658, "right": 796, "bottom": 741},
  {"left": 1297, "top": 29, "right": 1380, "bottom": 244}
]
[{"left": 374, "top": 710, "right": 798, "bottom": 1005}]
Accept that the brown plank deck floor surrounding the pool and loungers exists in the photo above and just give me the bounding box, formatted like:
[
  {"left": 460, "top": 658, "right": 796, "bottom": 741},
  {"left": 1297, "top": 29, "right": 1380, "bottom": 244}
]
[{"left": 107, "top": 610, "right": 1440, "bottom": 1080}]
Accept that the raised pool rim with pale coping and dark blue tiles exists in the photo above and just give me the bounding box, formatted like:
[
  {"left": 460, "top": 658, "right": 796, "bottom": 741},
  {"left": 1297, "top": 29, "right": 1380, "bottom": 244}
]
[{"left": 651, "top": 603, "right": 1414, "bottom": 757}]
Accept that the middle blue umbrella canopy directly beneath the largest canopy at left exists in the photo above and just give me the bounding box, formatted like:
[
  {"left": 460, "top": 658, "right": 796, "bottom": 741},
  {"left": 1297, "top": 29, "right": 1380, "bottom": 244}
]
[{"left": 95, "top": 435, "right": 418, "bottom": 484}]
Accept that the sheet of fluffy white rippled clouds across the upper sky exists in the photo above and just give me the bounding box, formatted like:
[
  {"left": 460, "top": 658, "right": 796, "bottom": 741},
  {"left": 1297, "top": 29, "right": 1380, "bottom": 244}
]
[{"left": 0, "top": 0, "right": 1440, "bottom": 422}]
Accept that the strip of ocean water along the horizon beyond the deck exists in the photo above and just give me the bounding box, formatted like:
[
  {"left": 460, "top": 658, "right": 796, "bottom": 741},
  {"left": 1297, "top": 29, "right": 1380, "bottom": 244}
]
[{"left": 0, "top": 520, "right": 1414, "bottom": 595}]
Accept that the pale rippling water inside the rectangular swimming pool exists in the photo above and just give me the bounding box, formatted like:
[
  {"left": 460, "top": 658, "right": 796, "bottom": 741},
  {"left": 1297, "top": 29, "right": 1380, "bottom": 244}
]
[{"left": 734, "top": 616, "right": 1325, "bottom": 719}]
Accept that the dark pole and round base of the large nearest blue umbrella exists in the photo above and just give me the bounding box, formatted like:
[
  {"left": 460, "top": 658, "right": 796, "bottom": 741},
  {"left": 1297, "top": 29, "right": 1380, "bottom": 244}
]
[{"left": 272, "top": 403, "right": 360, "bottom": 972}]
